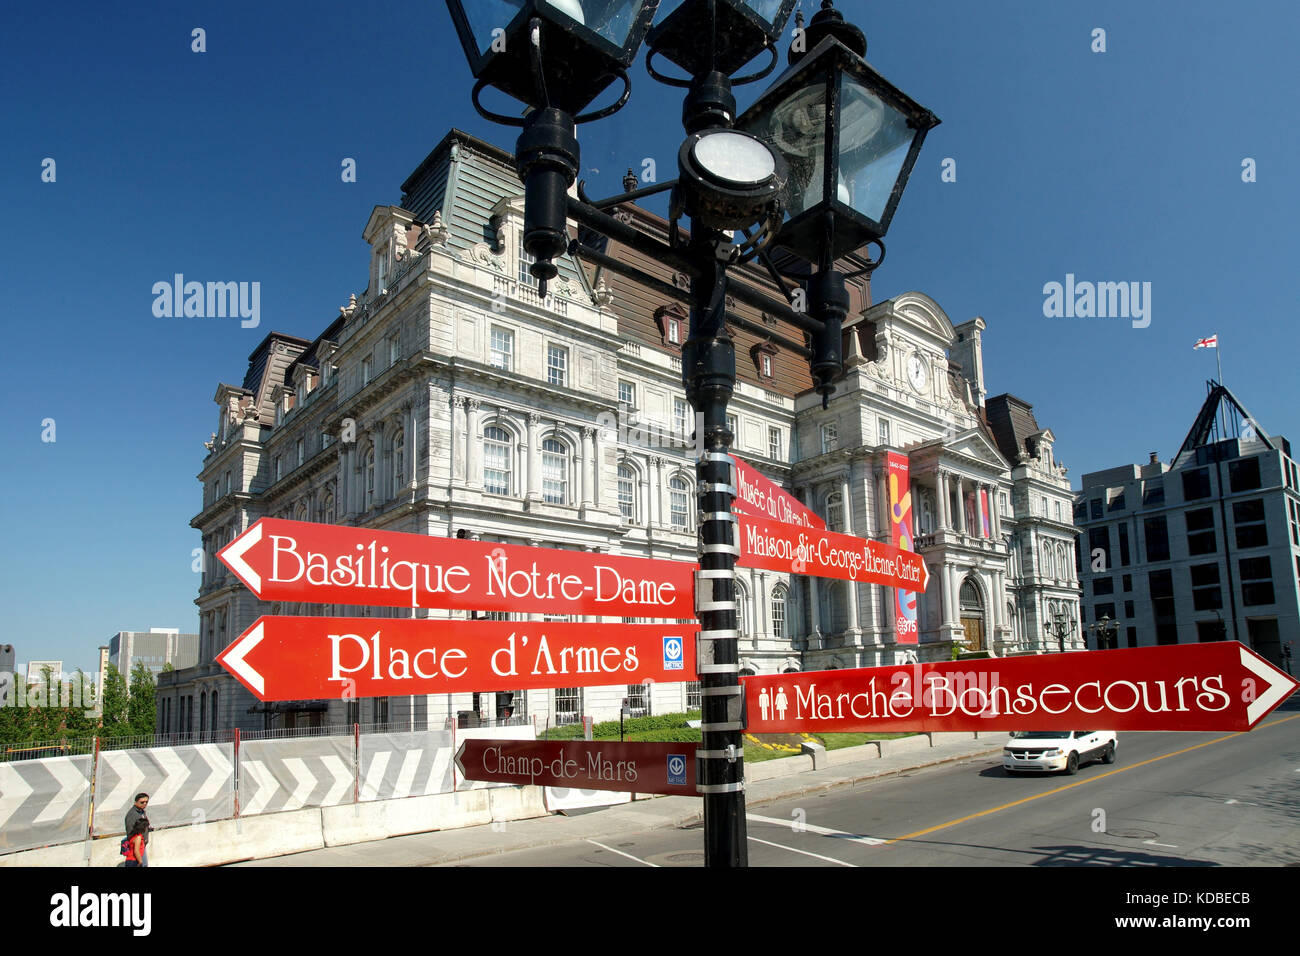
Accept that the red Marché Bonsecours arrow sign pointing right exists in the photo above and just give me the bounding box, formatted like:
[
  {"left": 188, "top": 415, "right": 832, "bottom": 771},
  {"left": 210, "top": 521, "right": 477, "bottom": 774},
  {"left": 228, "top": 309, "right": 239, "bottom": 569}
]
[{"left": 741, "top": 641, "right": 1300, "bottom": 734}]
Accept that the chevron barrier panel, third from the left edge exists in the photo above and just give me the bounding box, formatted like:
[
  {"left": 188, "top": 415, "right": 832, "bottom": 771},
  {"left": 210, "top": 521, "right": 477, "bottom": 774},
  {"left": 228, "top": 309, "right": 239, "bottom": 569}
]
[{"left": 239, "top": 735, "right": 356, "bottom": 817}]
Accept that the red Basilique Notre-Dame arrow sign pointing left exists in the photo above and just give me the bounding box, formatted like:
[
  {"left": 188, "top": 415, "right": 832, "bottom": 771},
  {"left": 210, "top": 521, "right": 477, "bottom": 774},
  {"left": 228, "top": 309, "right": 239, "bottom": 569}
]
[{"left": 217, "top": 518, "right": 697, "bottom": 620}]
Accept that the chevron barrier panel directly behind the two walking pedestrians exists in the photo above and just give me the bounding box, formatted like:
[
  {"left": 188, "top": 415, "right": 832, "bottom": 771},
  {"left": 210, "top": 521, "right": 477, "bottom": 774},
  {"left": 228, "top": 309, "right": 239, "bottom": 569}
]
[{"left": 95, "top": 744, "right": 235, "bottom": 835}]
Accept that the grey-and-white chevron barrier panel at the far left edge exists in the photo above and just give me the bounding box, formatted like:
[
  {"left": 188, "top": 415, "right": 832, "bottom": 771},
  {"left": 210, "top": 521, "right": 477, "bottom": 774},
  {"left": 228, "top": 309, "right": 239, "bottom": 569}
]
[{"left": 0, "top": 754, "right": 95, "bottom": 853}]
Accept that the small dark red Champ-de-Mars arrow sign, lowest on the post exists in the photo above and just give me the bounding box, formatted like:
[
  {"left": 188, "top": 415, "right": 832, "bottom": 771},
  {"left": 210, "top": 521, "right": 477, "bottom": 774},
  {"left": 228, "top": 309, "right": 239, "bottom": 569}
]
[{"left": 456, "top": 737, "right": 699, "bottom": 796}]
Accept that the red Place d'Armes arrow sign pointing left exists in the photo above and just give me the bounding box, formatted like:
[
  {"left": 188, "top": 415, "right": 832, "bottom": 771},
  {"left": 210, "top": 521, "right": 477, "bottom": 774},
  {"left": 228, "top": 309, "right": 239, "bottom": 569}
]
[{"left": 217, "top": 617, "right": 699, "bottom": 701}]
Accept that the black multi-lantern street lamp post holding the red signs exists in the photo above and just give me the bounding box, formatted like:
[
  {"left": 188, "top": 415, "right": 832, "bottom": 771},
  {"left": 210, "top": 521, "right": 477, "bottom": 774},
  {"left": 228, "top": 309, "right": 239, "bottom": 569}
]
[{"left": 447, "top": 0, "right": 939, "bottom": 866}]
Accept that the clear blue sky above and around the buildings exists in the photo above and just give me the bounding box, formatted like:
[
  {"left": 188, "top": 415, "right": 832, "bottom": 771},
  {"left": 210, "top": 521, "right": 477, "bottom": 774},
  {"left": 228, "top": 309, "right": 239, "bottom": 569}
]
[{"left": 0, "top": 0, "right": 1300, "bottom": 670}]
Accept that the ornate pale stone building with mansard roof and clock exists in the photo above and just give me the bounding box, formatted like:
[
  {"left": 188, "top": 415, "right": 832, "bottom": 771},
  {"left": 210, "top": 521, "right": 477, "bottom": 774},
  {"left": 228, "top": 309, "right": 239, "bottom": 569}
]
[{"left": 159, "top": 131, "right": 1078, "bottom": 731}]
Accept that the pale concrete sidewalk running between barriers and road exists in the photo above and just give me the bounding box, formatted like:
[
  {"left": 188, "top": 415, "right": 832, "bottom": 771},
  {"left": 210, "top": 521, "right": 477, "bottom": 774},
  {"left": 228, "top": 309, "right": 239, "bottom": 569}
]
[{"left": 234, "top": 734, "right": 1008, "bottom": 866}]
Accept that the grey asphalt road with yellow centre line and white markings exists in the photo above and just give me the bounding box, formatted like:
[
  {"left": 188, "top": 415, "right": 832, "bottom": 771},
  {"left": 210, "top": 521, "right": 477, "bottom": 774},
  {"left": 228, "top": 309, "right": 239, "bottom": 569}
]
[{"left": 441, "top": 700, "right": 1300, "bottom": 868}]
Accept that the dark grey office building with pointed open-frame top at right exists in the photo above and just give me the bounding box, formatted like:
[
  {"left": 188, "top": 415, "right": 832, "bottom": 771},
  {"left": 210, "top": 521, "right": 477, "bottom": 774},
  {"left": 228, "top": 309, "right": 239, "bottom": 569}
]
[{"left": 1074, "top": 382, "right": 1300, "bottom": 667}]
